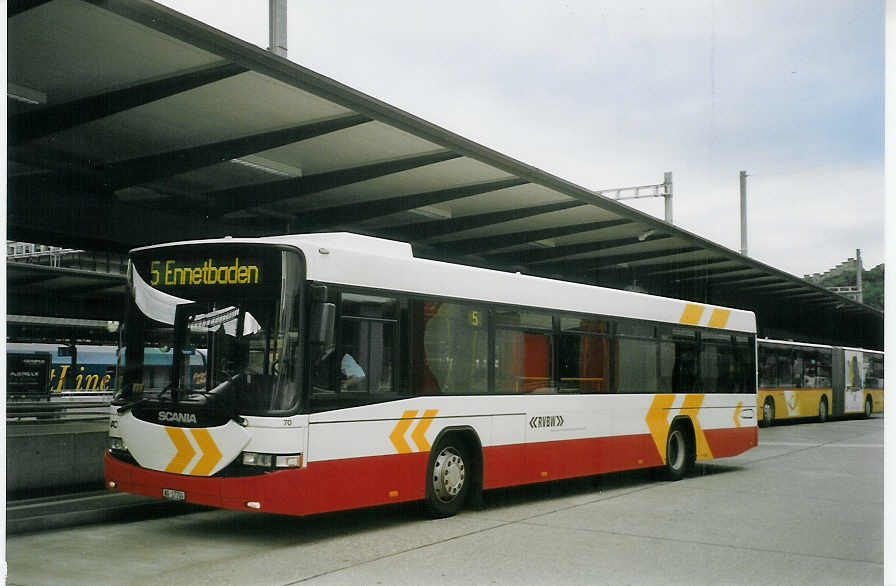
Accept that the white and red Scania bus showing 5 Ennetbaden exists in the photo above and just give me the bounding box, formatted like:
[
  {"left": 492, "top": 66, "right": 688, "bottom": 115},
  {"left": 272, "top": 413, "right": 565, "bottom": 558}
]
[{"left": 105, "top": 233, "right": 758, "bottom": 516}]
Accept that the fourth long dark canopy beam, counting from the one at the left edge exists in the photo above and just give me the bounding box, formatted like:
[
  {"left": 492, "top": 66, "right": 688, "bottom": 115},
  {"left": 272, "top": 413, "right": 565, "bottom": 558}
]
[{"left": 296, "top": 177, "right": 528, "bottom": 231}]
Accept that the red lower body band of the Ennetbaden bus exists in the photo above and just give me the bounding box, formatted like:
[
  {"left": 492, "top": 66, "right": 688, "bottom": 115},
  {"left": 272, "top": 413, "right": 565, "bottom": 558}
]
[{"left": 105, "top": 427, "right": 758, "bottom": 515}]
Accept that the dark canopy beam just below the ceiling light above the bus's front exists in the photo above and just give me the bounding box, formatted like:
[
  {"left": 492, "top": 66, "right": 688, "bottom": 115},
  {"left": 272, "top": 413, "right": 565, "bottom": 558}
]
[{"left": 204, "top": 150, "right": 460, "bottom": 216}]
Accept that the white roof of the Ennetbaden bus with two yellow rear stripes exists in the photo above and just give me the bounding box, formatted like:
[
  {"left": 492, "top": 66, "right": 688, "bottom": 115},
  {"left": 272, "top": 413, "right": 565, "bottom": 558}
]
[{"left": 135, "top": 232, "right": 756, "bottom": 333}]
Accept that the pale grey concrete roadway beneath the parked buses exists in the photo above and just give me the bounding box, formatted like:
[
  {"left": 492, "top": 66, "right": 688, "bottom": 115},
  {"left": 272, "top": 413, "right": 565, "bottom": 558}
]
[{"left": 7, "top": 417, "right": 884, "bottom": 586}]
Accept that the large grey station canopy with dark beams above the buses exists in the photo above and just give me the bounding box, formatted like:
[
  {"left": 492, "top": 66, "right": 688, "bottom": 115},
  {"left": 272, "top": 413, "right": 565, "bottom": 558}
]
[{"left": 7, "top": 0, "right": 883, "bottom": 347}]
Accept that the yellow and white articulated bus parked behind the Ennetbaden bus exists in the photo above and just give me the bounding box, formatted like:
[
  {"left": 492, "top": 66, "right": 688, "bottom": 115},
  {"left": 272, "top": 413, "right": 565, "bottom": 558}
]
[{"left": 756, "top": 339, "right": 884, "bottom": 427}]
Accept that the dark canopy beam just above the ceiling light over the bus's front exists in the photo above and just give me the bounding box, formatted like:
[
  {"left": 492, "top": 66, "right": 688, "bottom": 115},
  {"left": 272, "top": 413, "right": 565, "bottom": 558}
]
[{"left": 99, "top": 114, "right": 371, "bottom": 190}]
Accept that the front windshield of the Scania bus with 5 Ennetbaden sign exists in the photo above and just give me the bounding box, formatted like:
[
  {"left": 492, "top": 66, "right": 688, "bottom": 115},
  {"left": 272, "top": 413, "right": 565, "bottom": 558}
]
[{"left": 118, "top": 245, "right": 303, "bottom": 416}]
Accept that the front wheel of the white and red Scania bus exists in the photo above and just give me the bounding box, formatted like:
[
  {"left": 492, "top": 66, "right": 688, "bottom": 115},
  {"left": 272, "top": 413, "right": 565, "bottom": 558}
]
[{"left": 425, "top": 438, "right": 472, "bottom": 518}]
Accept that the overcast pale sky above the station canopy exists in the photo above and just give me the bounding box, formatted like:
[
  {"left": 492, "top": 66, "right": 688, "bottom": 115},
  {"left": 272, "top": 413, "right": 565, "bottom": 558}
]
[{"left": 162, "top": 0, "right": 884, "bottom": 276}]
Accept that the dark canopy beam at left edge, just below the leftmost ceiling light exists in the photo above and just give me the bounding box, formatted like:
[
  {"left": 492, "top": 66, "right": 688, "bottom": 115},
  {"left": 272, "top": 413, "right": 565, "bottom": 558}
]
[{"left": 6, "top": 63, "right": 248, "bottom": 146}]
